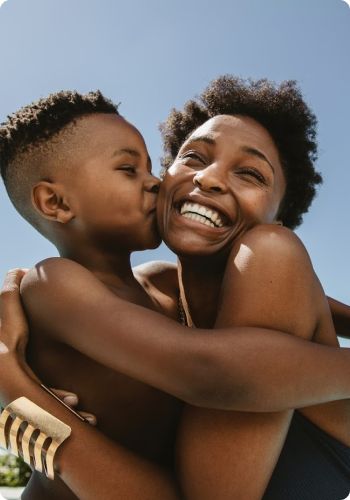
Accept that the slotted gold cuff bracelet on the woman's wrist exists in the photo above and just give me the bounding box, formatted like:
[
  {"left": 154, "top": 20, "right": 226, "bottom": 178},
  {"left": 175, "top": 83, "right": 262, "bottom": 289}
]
[{"left": 0, "top": 397, "right": 72, "bottom": 479}]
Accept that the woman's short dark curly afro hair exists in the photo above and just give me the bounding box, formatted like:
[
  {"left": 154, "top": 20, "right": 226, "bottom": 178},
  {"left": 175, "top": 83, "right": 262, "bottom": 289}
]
[{"left": 160, "top": 75, "right": 322, "bottom": 229}]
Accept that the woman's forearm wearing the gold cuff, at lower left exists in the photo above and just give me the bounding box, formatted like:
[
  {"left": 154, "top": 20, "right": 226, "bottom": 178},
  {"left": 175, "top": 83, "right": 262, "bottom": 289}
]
[{"left": 0, "top": 366, "right": 179, "bottom": 500}]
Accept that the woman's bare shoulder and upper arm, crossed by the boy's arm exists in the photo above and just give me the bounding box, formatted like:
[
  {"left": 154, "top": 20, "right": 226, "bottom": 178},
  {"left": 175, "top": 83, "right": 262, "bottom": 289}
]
[{"left": 179, "top": 227, "right": 325, "bottom": 500}]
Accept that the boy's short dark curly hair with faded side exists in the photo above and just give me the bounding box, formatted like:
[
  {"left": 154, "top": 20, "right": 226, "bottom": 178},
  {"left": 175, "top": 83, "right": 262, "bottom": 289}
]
[{"left": 0, "top": 90, "right": 119, "bottom": 232}]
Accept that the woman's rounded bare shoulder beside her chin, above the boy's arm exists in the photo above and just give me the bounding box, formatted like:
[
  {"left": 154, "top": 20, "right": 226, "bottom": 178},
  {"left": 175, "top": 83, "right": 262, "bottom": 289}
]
[{"left": 222, "top": 225, "right": 325, "bottom": 338}]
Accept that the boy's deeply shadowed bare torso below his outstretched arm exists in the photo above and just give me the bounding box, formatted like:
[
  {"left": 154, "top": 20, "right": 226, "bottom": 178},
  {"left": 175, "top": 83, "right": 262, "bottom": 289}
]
[{"left": 28, "top": 334, "right": 182, "bottom": 466}]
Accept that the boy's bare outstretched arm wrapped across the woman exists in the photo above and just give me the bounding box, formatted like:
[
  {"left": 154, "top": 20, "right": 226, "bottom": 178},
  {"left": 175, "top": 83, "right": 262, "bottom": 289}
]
[{"left": 22, "top": 259, "right": 350, "bottom": 411}]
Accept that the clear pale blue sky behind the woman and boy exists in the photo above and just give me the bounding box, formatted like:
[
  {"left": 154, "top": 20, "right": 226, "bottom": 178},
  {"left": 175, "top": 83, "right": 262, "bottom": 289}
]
[{"left": 0, "top": 0, "right": 350, "bottom": 328}]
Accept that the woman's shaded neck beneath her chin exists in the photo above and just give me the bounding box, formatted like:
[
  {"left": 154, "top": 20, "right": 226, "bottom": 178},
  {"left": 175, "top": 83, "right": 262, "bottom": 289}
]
[{"left": 180, "top": 258, "right": 226, "bottom": 328}]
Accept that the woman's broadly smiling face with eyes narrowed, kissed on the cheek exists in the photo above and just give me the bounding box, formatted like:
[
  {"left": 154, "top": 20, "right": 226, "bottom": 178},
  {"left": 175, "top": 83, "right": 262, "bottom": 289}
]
[{"left": 158, "top": 115, "right": 286, "bottom": 256}]
